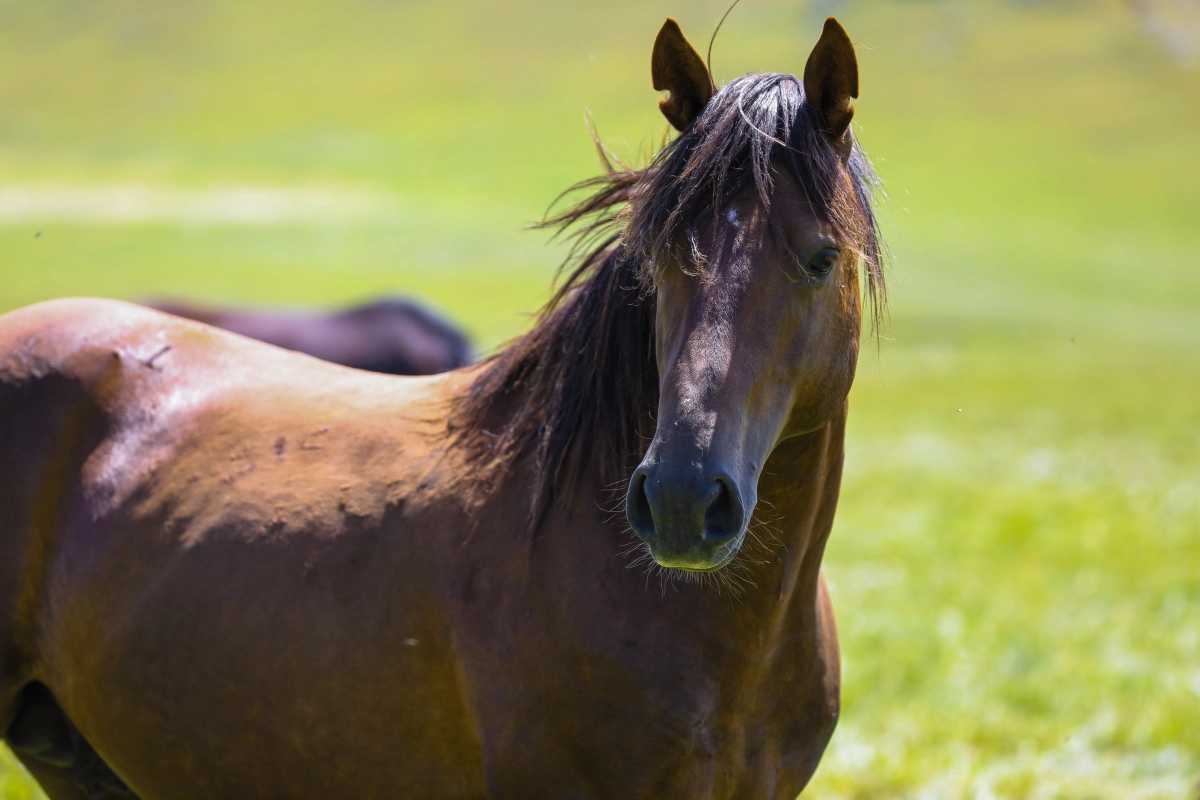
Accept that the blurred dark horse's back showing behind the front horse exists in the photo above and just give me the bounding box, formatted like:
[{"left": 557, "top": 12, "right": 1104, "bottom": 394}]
[{"left": 143, "top": 297, "right": 474, "bottom": 375}]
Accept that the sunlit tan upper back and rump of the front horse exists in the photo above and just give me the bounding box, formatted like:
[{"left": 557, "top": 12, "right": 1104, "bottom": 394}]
[{"left": 0, "top": 299, "right": 458, "bottom": 618}]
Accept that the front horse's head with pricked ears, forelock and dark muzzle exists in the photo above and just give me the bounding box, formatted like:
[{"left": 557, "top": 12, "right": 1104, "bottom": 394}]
[{"left": 624, "top": 18, "right": 878, "bottom": 572}]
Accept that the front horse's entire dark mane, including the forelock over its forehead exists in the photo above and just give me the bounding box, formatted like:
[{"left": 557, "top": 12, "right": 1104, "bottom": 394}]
[{"left": 451, "top": 73, "right": 887, "bottom": 525}]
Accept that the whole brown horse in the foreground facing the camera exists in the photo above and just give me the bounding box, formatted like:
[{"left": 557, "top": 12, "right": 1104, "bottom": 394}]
[{"left": 0, "top": 19, "right": 882, "bottom": 800}]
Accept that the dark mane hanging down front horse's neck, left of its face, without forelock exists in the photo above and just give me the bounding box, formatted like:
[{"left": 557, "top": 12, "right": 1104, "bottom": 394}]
[{"left": 454, "top": 158, "right": 659, "bottom": 524}]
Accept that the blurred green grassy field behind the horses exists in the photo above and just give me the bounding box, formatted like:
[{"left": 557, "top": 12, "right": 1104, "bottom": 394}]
[{"left": 0, "top": 0, "right": 1200, "bottom": 800}]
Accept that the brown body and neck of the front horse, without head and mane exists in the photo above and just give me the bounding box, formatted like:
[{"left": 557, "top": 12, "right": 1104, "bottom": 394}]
[{"left": 0, "top": 300, "right": 844, "bottom": 800}]
